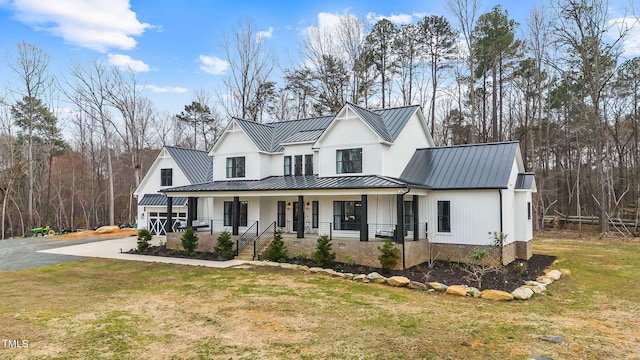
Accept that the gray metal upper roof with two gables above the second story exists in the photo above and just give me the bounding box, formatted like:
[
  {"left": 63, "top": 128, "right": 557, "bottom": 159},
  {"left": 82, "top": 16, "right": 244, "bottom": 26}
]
[{"left": 228, "top": 103, "right": 419, "bottom": 152}]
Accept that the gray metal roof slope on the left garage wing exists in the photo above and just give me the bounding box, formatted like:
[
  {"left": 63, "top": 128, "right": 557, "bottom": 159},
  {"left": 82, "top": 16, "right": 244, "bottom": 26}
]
[{"left": 165, "top": 146, "right": 213, "bottom": 184}]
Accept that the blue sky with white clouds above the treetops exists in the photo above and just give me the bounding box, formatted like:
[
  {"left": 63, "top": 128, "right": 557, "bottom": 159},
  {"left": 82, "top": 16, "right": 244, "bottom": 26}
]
[{"left": 0, "top": 0, "right": 640, "bottom": 118}]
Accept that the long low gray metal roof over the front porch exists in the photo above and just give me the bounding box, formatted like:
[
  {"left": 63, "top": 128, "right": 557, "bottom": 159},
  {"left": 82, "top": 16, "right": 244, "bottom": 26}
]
[{"left": 161, "top": 175, "right": 407, "bottom": 193}]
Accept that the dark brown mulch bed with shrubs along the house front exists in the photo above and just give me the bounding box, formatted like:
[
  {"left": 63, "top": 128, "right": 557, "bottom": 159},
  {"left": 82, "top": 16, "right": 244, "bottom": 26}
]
[{"left": 129, "top": 246, "right": 556, "bottom": 292}]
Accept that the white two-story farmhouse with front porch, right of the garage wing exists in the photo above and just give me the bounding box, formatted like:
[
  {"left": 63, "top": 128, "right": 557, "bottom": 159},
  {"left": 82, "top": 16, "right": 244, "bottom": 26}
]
[{"left": 139, "top": 103, "right": 535, "bottom": 267}]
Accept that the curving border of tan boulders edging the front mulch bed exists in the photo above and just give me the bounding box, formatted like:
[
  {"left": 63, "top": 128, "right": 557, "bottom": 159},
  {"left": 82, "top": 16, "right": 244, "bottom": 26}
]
[{"left": 232, "top": 261, "right": 571, "bottom": 301}]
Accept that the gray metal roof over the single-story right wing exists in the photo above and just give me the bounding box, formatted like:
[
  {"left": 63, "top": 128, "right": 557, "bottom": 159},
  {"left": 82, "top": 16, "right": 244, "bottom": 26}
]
[{"left": 400, "top": 142, "right": 518, "bottom": 189}]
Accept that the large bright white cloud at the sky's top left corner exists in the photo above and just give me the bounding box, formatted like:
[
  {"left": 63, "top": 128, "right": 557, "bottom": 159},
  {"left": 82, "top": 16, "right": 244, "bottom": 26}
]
[{"left": 12, "top": 0, "right": 152, "bottom": 52}]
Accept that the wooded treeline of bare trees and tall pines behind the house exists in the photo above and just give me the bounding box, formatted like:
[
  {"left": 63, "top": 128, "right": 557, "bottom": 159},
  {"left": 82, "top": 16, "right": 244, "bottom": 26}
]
[{"left": 0, "top": 0, "right": 640, "bottom": 236}]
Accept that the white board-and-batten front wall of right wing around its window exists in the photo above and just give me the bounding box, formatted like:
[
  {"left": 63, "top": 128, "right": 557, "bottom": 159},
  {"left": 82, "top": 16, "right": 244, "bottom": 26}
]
[{"left": 425, "top": 189, "right": 500, "bottom": 245}]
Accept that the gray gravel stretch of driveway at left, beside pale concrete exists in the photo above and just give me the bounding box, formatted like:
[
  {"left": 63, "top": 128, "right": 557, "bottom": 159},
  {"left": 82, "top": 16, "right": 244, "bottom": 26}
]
[{"left": 0, "top": 236, "right": 124, "bottom": 271}]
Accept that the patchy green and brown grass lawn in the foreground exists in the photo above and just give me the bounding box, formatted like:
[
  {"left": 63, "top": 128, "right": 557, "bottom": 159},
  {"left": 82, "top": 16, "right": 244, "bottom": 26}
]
[{"left": 0, "top": 235, "right": 640, "bottom": 359}]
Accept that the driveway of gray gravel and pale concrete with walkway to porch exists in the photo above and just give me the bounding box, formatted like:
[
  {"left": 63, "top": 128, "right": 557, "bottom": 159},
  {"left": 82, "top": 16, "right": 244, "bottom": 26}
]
[{"left": 0, "top": 236, "right": 245, "bottom": 271}]
